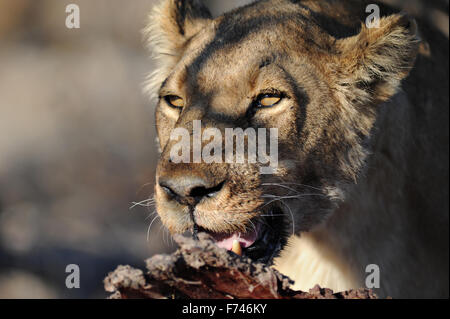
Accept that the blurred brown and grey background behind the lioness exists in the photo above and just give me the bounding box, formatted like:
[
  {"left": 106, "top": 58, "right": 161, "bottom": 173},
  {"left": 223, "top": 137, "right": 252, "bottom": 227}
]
[{"left": 0, "top": 0, "right": 448, "bottom": 298}]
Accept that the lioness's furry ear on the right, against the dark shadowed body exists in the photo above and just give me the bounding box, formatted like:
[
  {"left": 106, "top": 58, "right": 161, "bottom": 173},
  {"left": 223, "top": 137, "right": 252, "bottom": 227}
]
[{"left": 335, "top": 14, "right": 420, "bottom": 104}]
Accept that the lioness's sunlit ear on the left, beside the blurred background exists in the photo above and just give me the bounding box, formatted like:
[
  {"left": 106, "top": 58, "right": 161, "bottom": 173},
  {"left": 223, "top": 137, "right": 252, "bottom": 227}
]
[{"left": 143, "top": 0, "right": 212, "bottom": 96}]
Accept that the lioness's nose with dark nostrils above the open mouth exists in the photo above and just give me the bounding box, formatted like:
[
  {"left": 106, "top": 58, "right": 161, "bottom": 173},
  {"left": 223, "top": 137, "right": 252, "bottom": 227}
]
[{"left": 159, "top": 176, "right": 225, "bottom": 205}]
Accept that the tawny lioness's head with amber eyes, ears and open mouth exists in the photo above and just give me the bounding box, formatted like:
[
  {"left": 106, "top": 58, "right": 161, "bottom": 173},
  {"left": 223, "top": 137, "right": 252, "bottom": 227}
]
[{"left": 147, "top": 0, "right": 418, "bottom": 262}]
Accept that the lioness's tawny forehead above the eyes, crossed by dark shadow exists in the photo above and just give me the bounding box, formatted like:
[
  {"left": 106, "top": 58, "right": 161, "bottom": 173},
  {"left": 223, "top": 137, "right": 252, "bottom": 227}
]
[{"left": 162, "top": 1, "right": 331, "bottom": 112}]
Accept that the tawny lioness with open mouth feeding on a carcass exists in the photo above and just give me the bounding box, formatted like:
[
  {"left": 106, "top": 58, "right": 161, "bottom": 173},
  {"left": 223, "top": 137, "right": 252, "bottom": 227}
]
[{"left": 146, "top": 0, "right": 449, "bottom": 297}]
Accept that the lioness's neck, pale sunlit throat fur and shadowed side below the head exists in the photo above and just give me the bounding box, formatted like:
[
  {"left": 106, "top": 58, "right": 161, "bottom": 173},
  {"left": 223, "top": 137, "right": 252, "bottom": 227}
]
[{"left": 276, "top": 93, "right": 445, "bottom": 297}]
